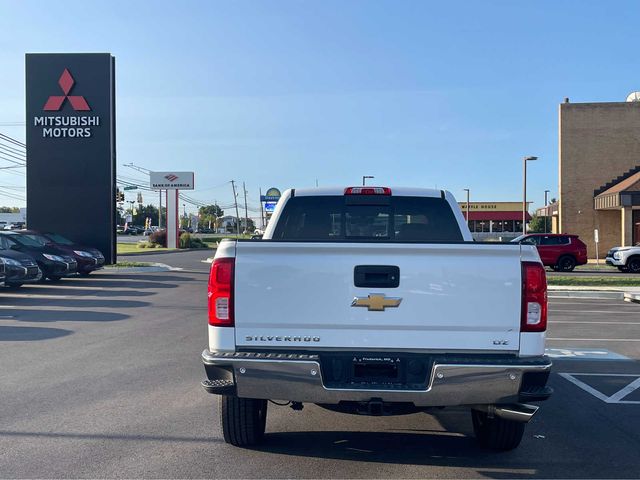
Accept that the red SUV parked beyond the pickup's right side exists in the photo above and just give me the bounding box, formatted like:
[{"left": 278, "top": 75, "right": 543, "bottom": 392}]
[{"left": 511, "top": 233, "right": 587, "bottom": 272}]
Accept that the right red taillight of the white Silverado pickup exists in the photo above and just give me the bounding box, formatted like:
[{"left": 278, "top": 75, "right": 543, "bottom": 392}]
[{"left": 520, "top": 262, "right": 547, "bottom": 332}]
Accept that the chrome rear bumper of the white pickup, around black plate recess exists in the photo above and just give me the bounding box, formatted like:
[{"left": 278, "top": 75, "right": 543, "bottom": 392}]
[{"left": 202, "top": 350, "right": 551, "bottom": 407}]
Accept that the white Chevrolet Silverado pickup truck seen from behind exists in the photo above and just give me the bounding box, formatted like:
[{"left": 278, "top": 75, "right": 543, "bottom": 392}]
[{"left": 202, "top": 187, "right": 552, "bottom": 450}]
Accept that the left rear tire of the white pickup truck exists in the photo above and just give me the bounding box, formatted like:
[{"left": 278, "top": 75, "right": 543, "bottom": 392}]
[{"left": 220, "top": 395, "right": 267, "bottom": 447}]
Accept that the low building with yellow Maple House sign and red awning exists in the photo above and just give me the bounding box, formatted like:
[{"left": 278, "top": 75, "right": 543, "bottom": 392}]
[{"left": 458, "top": 202, "right": 531, "bottom": 240}]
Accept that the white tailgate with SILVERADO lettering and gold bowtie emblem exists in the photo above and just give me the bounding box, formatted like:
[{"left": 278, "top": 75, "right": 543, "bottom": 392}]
[{"left": 235, "top": 241, "right": 522, "bottom": 352}]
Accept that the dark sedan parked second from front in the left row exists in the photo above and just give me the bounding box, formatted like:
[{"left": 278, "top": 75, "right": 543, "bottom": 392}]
[{"left": 0, "top": 230, "right": 78, "bottom": 281}]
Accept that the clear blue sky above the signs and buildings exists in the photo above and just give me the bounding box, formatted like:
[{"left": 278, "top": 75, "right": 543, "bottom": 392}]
[{"left": 0, "top": 0, "right": 640, "bottom": 215}]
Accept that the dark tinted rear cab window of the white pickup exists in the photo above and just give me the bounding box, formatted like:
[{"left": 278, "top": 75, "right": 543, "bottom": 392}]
[{"left": 273, "top": 195, "right": 463, "bottom": 243}]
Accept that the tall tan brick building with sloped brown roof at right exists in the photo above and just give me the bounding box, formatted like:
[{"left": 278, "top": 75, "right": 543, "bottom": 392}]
[{"left": 556, "top": 100, "right": 640, "bottom": 257}]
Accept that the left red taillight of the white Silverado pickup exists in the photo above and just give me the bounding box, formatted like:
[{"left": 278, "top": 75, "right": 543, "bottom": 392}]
[{"left": 207, "top": 258, "right": 235, "bottom": 327}]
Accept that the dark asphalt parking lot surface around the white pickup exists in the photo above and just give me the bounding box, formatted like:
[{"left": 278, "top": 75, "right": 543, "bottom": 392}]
[{"left": 0, "top": 251, "right": 640, "bottom": 479}]
